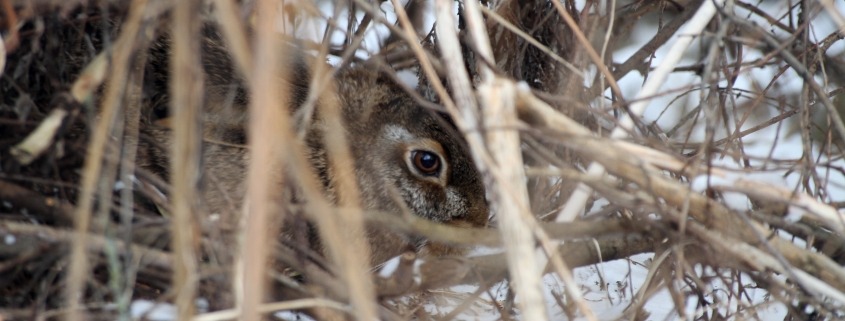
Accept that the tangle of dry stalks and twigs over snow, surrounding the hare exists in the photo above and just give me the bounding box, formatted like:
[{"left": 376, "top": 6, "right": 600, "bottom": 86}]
[{"left": 0, "top": 0, "right": 845, "bottom": 320}]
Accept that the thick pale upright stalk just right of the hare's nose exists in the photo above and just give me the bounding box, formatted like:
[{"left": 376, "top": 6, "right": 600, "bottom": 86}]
[{"left": 458, "top": 3, "right": 549, "bottom": 320}]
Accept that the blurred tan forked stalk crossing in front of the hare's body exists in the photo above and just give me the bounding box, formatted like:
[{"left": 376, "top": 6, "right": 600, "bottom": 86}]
[{"left": 244, "top": 1, "right": 377, "bottom": 320}]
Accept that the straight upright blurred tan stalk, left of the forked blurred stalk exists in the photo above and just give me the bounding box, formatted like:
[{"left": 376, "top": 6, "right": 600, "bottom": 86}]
[{"left": 170, "top": 0, "right": 204, "bottom": 320}]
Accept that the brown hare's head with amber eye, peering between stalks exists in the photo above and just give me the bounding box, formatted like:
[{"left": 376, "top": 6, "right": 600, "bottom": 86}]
[{"left": 324, "top": 68, "right": 488, "bottom": 260}]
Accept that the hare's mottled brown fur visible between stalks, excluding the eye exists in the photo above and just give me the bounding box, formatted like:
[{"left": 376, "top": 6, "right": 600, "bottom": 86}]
[{"left": 141, "top": 32, "right": 488, "bottom": 264}]
